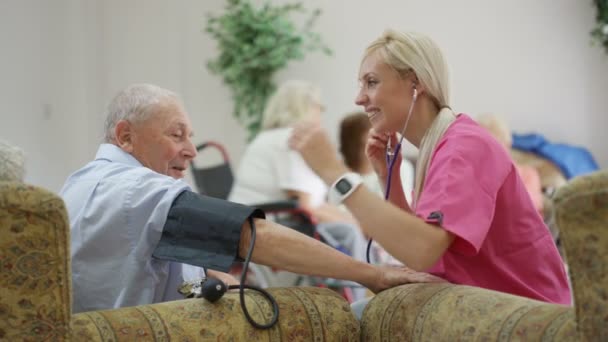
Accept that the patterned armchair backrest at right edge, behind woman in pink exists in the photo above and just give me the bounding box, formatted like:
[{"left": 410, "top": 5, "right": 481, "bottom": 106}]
[{"left": 554, "top": 170, "right": 608, "bottom": 341}]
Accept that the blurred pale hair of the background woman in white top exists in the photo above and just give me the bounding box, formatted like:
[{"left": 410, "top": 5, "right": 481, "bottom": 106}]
[{"left": 262, "top": 80, "right": 321, "bottom": 130}]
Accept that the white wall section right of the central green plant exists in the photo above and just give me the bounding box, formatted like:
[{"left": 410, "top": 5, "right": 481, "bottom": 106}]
[{"left": 274, "top": 0, "right": 608, "bottom": 167}]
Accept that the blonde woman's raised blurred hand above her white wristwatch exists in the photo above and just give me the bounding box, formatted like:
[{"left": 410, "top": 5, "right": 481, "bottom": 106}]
[{"left": 289, "top": 121, "right": 348, "bottom": 184}]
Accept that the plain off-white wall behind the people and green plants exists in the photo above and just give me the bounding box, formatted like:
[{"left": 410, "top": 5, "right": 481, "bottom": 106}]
[{"left": 0, "top": 0, "right": 608, "bottom": 191}]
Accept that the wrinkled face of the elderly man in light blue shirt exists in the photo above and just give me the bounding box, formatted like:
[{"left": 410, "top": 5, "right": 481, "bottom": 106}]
[{"left": 128, "top": 100, "right": 196, "bottom": 179}]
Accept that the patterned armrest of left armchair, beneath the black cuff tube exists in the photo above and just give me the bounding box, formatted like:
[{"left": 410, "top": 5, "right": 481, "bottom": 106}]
[{"left": 72, "top": 287, "right": 360, "bottom": 341}]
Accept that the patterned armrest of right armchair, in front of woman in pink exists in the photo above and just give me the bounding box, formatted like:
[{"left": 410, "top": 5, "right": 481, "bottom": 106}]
[{"left": 361, "top": 284, "right": 577, "bottom": 342}]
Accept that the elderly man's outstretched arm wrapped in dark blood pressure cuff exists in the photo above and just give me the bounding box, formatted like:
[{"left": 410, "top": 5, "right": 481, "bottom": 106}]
[{"left": 153, "top": 191, "right": 439, "bottom": 292}]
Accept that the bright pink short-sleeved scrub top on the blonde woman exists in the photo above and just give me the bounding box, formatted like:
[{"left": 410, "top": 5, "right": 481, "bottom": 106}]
[{"left": 414, "top": 114, "right": 571, "bottom": 305}]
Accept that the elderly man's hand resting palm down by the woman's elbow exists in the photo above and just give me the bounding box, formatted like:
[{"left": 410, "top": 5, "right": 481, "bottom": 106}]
[{"left": 369, "top": 266, "right": 447, "bottom": 293}]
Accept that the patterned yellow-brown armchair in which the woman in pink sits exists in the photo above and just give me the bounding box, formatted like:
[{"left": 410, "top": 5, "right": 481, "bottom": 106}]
[{"left": 361, "top": 170, "right": 608, "bottom": 342}]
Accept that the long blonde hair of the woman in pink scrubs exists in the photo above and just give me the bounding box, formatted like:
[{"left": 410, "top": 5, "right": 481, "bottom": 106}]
[{"left": 363, "top": 29, "right": 455, "bottom": 202}]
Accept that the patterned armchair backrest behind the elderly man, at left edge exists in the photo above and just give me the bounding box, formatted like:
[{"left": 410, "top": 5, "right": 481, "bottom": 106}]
[{"left": 0, "top": 182, "right": 72, "bottom": 341}]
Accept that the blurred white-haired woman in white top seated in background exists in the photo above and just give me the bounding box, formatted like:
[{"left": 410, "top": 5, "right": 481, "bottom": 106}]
[{"left": 228, "top": 80, "right": 355, "bottom": 223}]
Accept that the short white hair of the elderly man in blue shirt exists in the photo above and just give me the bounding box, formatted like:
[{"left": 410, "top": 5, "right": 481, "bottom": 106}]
[{"left": 104, "top": 83, "right": 178, "bottom": 143}]
